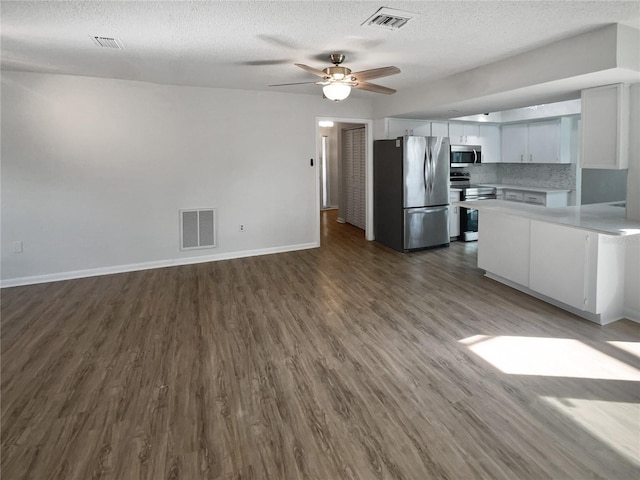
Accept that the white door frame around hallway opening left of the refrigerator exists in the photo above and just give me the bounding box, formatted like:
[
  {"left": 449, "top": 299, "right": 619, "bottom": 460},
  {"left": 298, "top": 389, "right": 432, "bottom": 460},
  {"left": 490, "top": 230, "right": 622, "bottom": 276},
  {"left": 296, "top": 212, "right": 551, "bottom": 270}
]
[{"left": 314, "top": 116, "right": 375, "bottom": 245}]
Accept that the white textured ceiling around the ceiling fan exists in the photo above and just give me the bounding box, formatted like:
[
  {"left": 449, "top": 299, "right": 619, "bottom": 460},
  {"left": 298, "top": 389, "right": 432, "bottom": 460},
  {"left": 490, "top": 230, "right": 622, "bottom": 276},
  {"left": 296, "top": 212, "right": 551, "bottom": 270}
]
[{"left": 1, "top": 0, "right": 640, "bottom": 98}]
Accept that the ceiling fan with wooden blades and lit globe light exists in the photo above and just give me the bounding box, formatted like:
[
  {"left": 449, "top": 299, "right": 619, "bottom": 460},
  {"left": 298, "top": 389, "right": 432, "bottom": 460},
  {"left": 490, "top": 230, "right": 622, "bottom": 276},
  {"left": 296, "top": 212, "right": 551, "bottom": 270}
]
[{"left": 269, "top": 53, "right": 400, "bottom": 102}]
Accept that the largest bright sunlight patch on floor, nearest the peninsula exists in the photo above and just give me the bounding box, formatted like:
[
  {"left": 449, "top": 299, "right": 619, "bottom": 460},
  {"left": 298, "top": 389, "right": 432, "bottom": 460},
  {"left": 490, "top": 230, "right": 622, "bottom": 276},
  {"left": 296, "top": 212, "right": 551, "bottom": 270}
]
[{"left": 460, "top": 335, "right": 640, "bottom": 382}]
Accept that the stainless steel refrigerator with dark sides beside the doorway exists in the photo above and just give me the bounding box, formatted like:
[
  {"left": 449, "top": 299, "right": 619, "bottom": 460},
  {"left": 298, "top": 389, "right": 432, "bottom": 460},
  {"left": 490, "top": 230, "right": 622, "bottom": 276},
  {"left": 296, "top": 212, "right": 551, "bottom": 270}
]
[{"left": 373, "top": 136, "right": 450, "bottom": 252}]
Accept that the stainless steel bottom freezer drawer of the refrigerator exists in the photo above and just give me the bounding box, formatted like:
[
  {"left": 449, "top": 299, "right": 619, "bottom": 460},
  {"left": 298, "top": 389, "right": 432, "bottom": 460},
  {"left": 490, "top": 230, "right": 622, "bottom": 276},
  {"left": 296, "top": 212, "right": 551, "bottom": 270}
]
[{"left": 403, "top": 205, "right": 449, "bottom": 250}]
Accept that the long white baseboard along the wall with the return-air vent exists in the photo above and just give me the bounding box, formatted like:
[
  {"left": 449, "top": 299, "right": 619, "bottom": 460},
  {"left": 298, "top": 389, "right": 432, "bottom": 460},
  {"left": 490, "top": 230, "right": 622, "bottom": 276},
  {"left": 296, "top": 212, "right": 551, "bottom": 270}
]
[{"left": 0, "top": 242, "right": 320, "bottom": 288}]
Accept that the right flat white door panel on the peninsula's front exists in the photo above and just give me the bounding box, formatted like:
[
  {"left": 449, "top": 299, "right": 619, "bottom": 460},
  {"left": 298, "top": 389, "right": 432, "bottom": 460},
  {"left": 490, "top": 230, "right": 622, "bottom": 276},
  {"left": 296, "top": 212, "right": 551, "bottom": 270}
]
[{"left": 529, "top": 220, "right": 593, "bottom": 310}]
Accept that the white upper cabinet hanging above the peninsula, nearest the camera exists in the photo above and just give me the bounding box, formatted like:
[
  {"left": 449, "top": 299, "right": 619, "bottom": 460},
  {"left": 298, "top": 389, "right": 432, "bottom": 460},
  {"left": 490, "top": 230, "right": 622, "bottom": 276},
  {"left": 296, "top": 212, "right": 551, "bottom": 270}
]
[{"left": 582, "top": 84, "right": 629, "bottom": 169}]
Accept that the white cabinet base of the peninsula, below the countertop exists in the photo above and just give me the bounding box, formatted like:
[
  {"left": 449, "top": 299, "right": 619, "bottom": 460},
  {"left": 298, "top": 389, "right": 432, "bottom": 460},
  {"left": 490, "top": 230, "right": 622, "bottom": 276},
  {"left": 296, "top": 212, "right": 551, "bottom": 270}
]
[{"left": 478, "top": 211, "right": 626, "bottom": 325}]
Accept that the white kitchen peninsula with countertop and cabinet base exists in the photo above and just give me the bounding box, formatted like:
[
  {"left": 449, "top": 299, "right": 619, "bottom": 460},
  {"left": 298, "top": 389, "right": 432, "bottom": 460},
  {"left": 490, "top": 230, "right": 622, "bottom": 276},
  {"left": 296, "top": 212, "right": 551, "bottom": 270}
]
[{"left": 457, "top": 200, "right": 640, "bottom": 325}]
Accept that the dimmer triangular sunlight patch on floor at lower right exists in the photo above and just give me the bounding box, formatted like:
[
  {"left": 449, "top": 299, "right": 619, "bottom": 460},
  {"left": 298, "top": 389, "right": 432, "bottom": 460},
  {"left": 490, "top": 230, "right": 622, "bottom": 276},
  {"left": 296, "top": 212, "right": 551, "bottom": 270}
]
[{"left": 540, "top": 397, "right": 640, "bottom": 465}]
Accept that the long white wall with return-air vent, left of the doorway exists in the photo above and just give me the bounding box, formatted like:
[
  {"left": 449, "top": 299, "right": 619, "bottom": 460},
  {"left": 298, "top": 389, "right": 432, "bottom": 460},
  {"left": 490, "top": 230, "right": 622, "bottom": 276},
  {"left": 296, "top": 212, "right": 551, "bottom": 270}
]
[{"left": 1, "top": 72, "right": 371, "bottom": 285}]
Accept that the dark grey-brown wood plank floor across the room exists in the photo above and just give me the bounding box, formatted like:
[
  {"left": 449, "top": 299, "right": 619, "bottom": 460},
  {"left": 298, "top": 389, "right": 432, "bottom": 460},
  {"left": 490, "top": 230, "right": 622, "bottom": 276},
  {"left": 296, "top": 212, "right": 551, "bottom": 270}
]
[{"left": 1, "top": 211, "right": 640, "bottom": 480}]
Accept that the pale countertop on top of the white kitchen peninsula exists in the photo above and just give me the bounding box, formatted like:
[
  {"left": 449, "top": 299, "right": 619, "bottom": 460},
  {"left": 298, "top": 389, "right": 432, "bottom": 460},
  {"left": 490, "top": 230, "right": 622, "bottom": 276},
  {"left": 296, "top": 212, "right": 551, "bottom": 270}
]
[{"left": 453, "top": 200, "right": 640, "bottom": 236}]
